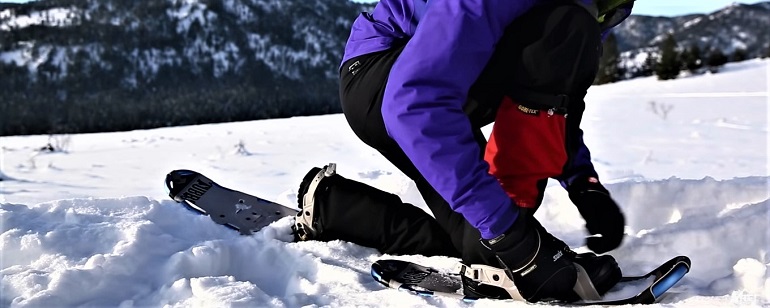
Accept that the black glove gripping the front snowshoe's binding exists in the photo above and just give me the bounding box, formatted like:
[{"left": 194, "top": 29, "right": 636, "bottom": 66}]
[{"left": 481, "top": 215, "right": 577, "bottom": 302}]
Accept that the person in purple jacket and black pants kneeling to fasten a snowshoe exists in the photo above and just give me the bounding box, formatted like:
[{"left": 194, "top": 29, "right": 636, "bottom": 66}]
[{"left": 293, "top": 0, "right": 633, "bottom": 302}]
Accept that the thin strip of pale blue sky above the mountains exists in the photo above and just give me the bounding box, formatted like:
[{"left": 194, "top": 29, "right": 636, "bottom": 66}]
[{"left": 0, "top": 0, "right": 767, "bottom": 16}]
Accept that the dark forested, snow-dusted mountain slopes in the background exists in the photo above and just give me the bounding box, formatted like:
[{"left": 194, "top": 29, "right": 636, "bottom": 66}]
[{"left": 0, "top": 0, "right": 770, "bottom": 135}]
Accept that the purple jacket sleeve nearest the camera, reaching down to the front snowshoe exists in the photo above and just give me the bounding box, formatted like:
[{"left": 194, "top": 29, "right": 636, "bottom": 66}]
[{"left": 382, "top": 0, "right": 536, "bottom": 239}]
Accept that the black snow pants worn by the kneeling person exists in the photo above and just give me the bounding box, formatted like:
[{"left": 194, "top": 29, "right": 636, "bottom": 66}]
[{"left": 318, "top": 4, "right": 601, "bottom": 265}]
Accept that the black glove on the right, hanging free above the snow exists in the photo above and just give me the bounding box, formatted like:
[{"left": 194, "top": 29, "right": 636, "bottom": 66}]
[{"left": 568, "top": 177, "right": 626, "bottom": 253}]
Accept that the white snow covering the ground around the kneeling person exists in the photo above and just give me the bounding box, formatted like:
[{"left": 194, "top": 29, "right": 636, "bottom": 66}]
[{"left": 0, "top": 60, "right": 770, "bottom": 307}]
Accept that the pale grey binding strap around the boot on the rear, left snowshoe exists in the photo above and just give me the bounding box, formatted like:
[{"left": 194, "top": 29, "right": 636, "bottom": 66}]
[{"left": 291, "top": 163, "right": 337, "bottom": 242}]
